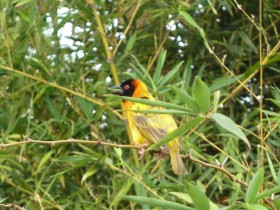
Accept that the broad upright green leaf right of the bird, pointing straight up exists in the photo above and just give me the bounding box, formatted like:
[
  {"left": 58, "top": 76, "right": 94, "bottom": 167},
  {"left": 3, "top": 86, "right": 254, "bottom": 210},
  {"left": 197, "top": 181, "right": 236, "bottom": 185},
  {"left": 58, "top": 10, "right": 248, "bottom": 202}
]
[{"left": 192, "top": 77, "right": 210, "bottom": 113}]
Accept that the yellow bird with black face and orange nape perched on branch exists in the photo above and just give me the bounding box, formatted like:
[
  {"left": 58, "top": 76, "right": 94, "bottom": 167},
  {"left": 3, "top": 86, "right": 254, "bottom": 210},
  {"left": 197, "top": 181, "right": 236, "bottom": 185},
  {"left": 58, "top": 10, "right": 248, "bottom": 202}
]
[{"left": 111, "top": 78, "right": 186, "bottom": 175}]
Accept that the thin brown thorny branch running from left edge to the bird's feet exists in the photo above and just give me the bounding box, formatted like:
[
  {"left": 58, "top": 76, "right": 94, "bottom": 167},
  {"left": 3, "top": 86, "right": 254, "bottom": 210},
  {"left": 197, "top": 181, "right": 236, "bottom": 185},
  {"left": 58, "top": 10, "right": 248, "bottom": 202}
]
[{"left": 0, "top": 137, "right": 142, "bottom": 149}]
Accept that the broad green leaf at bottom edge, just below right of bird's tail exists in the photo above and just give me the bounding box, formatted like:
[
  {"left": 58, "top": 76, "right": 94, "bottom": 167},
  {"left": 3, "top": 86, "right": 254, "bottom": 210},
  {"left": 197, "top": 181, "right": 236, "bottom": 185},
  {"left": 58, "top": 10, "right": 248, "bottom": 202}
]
[{"left": 187, "top": 183, "right": 210, "bottom": 210}]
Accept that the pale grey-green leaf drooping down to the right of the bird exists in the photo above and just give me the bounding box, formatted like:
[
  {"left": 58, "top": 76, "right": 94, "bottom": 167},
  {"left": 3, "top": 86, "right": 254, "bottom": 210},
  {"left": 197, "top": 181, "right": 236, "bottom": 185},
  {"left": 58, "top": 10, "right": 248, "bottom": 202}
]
[{"left": 211, "top": 113, "right": 251, "bottom": 149}]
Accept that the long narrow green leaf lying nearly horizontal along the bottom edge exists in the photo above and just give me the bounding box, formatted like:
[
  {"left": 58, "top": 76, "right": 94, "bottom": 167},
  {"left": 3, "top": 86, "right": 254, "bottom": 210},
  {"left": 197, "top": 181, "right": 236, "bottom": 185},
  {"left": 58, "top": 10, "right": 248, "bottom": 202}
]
[{"left": 122, "top": 195, "right": 194, "bottom": 210}]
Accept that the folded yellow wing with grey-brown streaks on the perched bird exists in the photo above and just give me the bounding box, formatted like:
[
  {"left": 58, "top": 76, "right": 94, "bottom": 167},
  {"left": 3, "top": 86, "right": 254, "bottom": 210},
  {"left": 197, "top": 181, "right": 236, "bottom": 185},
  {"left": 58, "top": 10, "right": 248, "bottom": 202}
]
[{"left": 132, "top": 103, "right": 177, "bottom": 143}]
